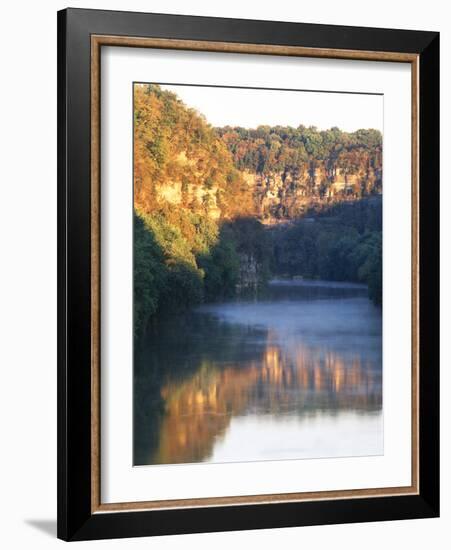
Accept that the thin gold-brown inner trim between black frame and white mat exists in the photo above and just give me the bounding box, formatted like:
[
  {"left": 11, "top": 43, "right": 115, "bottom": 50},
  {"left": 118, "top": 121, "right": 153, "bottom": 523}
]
[{"left": 91, "top": 35, "right": 419, "bottom": 514}]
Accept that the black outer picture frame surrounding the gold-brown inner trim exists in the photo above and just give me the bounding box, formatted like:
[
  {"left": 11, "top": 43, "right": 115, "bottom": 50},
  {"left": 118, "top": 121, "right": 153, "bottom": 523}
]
[{"left": 58, "top": 9, "right": 439, "bottom": 540}]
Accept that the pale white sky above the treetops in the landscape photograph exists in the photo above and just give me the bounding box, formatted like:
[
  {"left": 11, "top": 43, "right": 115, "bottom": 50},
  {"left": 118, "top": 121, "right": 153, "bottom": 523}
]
[{"left": 161, "top": 85, "right": 383, "bottom": 132}]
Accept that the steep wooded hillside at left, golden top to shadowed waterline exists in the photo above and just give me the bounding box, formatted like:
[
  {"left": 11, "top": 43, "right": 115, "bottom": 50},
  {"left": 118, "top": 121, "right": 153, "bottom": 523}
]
[{"left": 134, "top": 85, "right": 270, "bottom": 335}]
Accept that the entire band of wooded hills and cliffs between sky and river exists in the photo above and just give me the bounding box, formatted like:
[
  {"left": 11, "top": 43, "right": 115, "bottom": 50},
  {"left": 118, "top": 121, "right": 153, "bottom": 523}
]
[{"left": 134, "top": 85, "right": 382, "bottom": 336}]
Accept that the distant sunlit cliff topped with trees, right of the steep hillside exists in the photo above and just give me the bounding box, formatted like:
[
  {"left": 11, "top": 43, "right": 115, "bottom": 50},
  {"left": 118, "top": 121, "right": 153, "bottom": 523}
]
[{"left": 217, "top": 125, "right": 382, "bottom": 222}]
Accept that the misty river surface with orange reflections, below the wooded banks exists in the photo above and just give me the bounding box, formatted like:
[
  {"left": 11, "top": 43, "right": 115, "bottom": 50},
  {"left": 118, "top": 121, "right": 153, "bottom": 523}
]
[{"left": 134, "top": 282, "right": 383, "bottom": 465}]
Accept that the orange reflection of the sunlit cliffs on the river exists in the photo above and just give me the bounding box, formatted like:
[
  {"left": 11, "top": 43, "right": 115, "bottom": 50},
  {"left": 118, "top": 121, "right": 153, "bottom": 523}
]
[{"left": 152, "top": 338, "right": 382, "bottom": 464}]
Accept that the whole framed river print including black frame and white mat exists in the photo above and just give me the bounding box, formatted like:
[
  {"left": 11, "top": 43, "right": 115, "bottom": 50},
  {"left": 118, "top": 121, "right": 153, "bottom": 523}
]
[{"left": 58, "top": 9, "right": 439, "bottom": 540}]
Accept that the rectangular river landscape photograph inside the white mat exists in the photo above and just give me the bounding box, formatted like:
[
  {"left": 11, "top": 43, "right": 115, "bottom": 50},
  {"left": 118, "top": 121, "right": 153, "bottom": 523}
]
[{"left": 130, "top": 81, "right": 384, "bottom": 467}]
